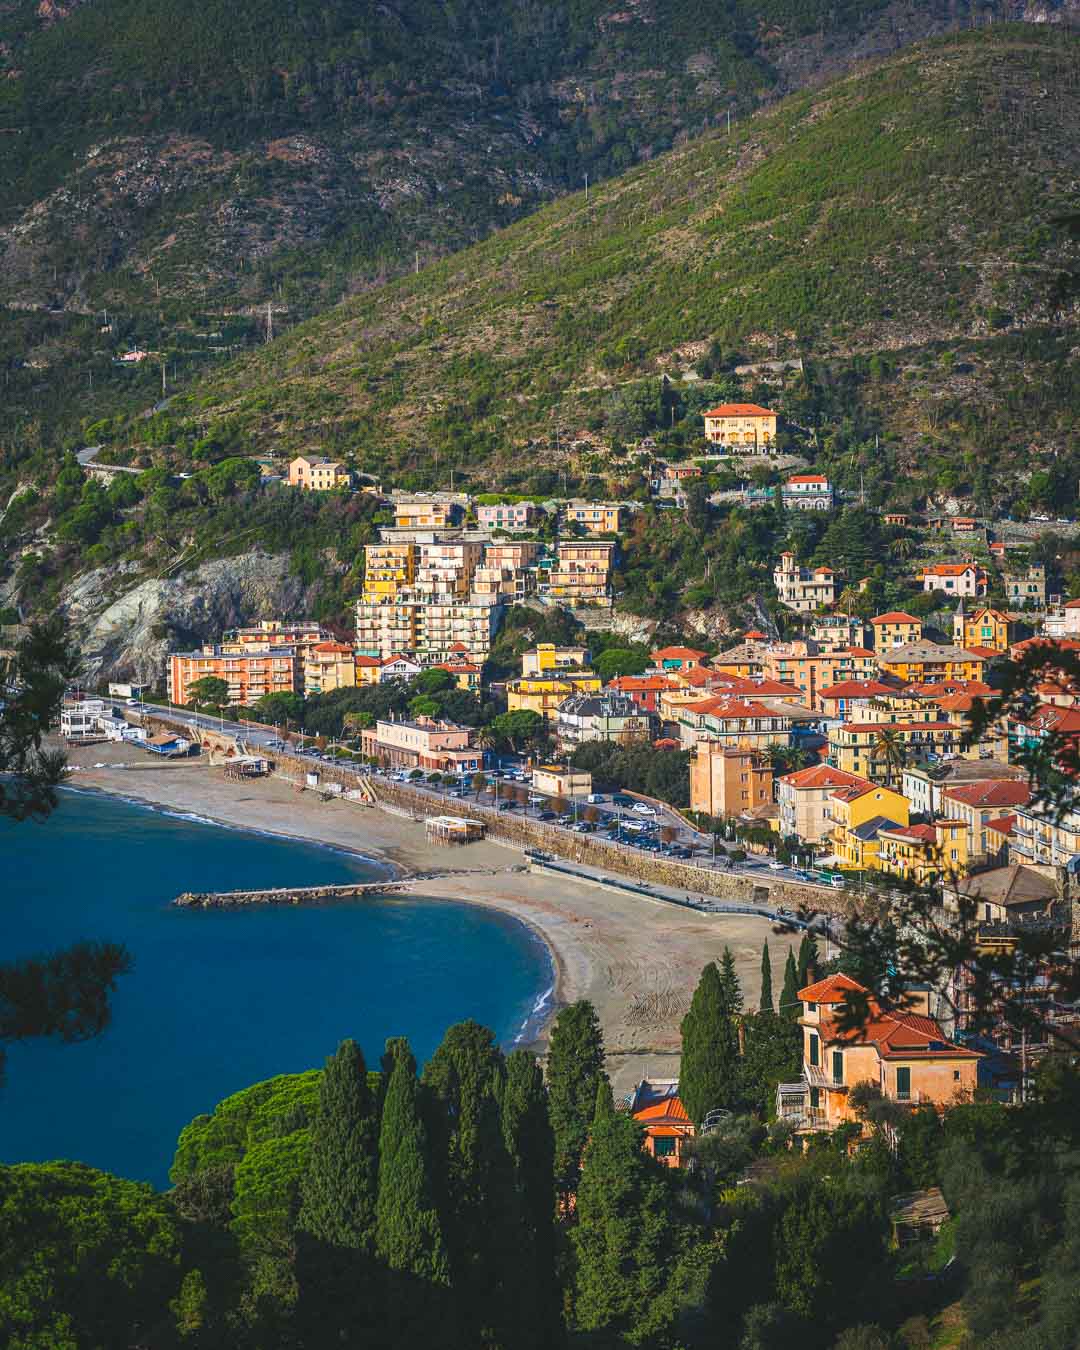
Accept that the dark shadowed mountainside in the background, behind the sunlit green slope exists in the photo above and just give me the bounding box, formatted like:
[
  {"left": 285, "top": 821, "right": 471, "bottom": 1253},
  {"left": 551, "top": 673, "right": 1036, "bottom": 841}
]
[{"left": 0, "top": 0, "right": 1075, "bottom": 436}]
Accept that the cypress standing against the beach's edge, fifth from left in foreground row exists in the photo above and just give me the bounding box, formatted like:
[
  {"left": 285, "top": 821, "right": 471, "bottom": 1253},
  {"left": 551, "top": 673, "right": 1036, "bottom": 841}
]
[{"left": 547, "top": 999, "right": 603, "bottom": 1191}]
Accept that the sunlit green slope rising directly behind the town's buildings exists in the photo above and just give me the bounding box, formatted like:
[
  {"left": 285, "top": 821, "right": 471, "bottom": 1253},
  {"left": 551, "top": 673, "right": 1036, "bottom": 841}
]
[{"left": 135, "top": 27, "right": 1080, "bottom": 497}]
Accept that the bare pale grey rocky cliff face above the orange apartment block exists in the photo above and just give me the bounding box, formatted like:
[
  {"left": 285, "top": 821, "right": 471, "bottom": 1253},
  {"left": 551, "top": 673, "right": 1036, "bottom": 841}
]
[{"left": 61, "top": 554, "right": 309, "bottom": 683}]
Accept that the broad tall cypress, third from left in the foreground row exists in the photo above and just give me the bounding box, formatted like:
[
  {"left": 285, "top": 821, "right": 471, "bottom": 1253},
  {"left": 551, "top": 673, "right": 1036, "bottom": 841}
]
[{"left": 421, "top": 1021, "right": 524, "bottom": 1346}]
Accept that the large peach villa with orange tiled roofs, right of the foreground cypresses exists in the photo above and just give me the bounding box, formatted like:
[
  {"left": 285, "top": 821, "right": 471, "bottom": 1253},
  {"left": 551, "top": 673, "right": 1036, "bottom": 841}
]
[{"left": 776, "top": 975, "right": 981, "bottom": 1134}]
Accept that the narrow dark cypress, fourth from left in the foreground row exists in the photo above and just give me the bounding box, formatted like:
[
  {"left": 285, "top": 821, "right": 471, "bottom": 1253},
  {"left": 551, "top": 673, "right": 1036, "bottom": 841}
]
[{"left": 502, "top": 1050, "right": 561, "bottom": 1350}]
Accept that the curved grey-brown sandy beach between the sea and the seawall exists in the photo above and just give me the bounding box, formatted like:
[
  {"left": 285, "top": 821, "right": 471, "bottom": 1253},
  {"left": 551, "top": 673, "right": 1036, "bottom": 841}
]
[{"left": 69, "top": 745, "right": 790, "bottom": 1094}]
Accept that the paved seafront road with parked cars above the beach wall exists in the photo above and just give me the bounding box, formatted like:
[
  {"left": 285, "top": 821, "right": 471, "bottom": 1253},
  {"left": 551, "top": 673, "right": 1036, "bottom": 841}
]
[{"left": 132, "top": 703, "right": 829, "bottom": 891}]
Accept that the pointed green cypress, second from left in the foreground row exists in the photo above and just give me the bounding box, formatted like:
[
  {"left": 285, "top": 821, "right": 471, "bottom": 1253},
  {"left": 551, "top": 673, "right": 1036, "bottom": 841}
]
[{"left": 375, "top": 1038, "right": 450, "bottom": 1347}]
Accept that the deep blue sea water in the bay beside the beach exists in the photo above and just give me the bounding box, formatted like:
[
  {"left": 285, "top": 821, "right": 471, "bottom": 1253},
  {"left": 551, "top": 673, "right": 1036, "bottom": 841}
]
[{"left": 0, "top": 792, "right": 554, "bottom": 1185}]
